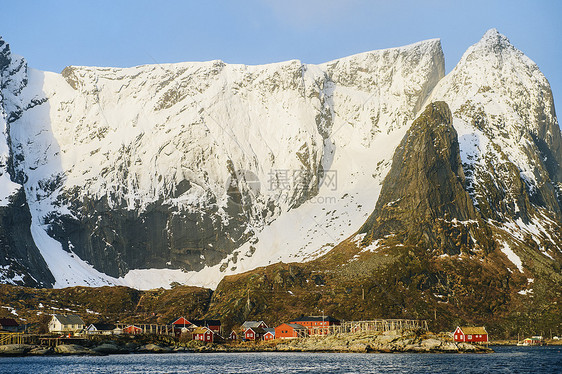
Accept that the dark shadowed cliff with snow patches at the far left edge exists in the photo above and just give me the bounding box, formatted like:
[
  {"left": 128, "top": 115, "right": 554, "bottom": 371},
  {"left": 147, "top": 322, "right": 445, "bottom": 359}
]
[{"left": 0, "top": 39, "right": 54, "bottom": 287}]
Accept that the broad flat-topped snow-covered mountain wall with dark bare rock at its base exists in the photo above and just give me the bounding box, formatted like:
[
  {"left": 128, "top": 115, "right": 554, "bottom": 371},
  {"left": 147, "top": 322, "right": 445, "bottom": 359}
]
[{"left": 10, "top": 40, "right": 444, "bottom": 288}]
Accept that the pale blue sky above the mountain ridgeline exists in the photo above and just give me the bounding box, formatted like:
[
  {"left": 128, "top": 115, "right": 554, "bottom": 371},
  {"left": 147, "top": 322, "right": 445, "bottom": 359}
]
[{"left": 0, "top": 0, "right": 562, "bottom": 113}]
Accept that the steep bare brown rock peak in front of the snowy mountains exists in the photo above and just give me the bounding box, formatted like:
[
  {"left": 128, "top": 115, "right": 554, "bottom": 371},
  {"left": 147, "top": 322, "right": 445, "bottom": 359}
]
[{"left": 359, "top": 102, "right": 488, "bottom": 254}]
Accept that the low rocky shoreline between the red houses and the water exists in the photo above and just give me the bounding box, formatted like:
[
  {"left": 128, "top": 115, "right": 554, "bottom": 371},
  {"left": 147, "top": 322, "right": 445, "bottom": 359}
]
[{"left": 0, "top": 331, "right": 493, "bottom": 356}]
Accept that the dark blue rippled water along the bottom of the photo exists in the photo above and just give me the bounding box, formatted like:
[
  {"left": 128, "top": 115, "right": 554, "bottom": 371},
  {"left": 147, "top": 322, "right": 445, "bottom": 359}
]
[{"left": 0, "top": 347, "right": 562, "bottom": 374}]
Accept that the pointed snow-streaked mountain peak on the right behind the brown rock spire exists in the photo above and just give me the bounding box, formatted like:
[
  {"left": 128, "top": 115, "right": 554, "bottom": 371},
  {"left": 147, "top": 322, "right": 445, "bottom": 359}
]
[{"left": 429, "top": 29, "right": 562, "bottom": 268}]
